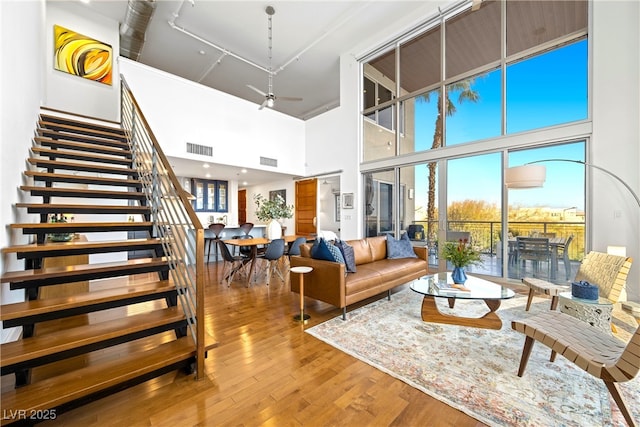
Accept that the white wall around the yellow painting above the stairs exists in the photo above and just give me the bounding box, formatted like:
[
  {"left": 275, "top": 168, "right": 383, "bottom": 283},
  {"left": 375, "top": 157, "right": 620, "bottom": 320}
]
[{"left": 45, "top": 2, "right": 120, "bottom": 121}]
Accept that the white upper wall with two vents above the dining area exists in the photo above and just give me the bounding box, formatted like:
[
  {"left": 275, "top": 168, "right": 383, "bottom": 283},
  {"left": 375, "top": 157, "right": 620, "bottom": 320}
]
[{"left": 120, "top": 58, "right": 305, "bottom": 175}]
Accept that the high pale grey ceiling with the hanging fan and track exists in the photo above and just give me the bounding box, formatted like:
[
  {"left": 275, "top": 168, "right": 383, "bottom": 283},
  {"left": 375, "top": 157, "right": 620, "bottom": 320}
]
[{"left": 80, "top": 0, "right": 445, "bottom": 119}]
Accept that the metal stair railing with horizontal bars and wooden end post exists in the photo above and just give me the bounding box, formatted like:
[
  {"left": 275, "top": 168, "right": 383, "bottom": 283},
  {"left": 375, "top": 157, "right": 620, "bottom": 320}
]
[{"left": 120, "top": 75, "right": 205, "bottom": 379}]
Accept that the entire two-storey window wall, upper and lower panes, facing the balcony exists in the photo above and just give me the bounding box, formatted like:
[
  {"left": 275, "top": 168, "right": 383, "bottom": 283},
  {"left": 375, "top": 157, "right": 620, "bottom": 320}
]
[{"left": 361, "top": 0, "right": 590, "bottom": 288}]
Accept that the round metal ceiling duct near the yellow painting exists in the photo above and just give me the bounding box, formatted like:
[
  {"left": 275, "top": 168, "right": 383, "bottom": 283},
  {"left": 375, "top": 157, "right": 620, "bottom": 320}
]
[{"left": 120, "top": 0, "right": 156, "bottom": 61}]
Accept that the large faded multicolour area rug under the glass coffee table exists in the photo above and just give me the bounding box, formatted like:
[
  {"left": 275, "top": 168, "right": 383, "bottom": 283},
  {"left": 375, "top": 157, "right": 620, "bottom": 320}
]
[{"left": 307, "top": 289, "right": 640, "bottom": 427}]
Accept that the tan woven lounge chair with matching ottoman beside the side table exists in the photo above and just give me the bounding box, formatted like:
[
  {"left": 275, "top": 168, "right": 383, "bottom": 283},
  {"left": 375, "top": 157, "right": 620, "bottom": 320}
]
[{"left": 522, "top": 251, "right": 633, "bottom": 311}]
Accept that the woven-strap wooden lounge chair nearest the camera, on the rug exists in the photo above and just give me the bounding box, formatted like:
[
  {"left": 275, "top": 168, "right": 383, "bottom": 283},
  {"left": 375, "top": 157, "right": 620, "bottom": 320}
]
[{"left": 511, "top": 311, "right": 640, "bottom": 426}]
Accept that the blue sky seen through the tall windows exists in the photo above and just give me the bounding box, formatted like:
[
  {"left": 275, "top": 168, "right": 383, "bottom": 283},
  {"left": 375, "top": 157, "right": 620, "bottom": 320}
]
[{"left": 415, "top": 40, "right": 588, "bottom": 210}]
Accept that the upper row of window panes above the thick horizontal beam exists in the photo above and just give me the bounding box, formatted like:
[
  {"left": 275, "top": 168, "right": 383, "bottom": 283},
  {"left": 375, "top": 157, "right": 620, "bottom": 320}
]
[{"left": 362, "top": 0, "right": 588, "bottom": 161}]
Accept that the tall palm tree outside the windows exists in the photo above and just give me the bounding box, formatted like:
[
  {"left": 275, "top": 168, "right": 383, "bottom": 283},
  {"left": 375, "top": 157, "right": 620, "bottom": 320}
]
[{"left": 422, "top": 79, "right": 480, "bottom": 241}]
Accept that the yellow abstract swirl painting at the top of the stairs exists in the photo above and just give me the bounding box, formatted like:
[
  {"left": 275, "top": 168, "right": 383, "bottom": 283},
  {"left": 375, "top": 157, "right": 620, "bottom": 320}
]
[{"left": 53, "top": 25, "right": 113, "bottom": 85}]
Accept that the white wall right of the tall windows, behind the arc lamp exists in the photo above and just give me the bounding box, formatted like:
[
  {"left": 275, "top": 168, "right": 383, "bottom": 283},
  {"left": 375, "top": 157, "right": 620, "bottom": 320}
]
[{"left": 589, "top": 1, "right": 640, "bottom": 301}]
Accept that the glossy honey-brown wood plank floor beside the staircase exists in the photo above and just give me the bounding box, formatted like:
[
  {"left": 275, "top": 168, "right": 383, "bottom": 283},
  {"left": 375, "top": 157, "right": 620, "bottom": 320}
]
[{"left": 15, "top": 263, "right": 484, "bottom": 427}]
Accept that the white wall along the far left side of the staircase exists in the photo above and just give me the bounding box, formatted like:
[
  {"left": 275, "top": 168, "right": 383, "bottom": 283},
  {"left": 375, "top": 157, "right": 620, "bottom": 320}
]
[{"left": 0, "top": 1, "right": 45, "bottom": 342}]
